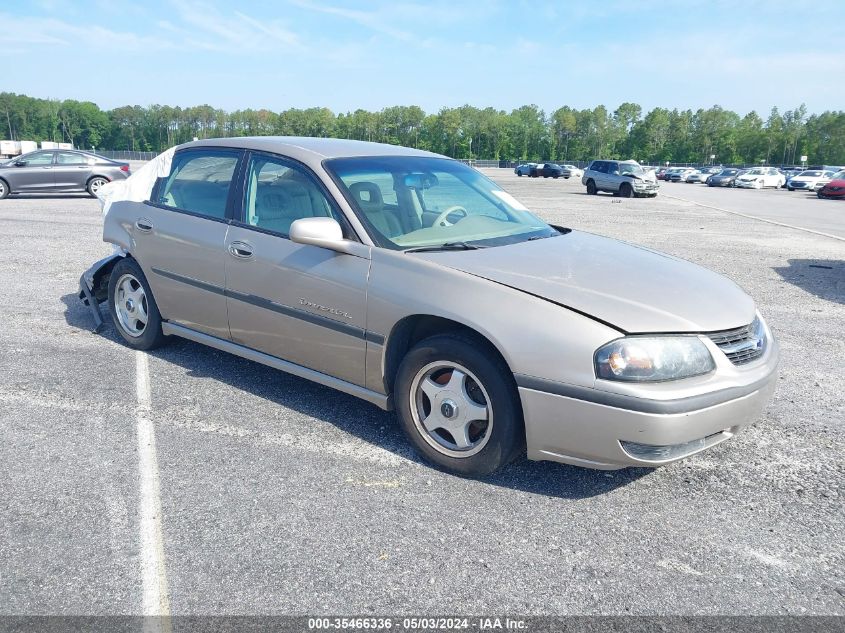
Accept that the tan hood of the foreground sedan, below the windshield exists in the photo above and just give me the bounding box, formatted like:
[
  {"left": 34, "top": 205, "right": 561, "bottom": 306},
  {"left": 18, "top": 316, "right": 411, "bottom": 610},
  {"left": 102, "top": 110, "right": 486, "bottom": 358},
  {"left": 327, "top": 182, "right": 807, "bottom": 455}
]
[{"left": 417, "top": 231, "right": 755, "bottom": 332}]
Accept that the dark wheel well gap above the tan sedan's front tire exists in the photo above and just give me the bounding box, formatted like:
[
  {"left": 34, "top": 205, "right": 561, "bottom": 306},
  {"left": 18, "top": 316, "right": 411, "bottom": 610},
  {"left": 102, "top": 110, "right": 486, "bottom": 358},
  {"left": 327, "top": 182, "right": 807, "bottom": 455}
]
[{"left": 384, "top": 314, "right": 508, "bottom": 393}]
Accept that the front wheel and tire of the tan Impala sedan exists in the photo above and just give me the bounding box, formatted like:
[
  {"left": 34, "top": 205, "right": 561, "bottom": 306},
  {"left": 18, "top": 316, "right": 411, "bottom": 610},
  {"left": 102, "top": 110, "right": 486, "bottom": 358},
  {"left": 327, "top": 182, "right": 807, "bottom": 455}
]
[{"left": 393, "top": 334, "right": 525, "bottom": 477}]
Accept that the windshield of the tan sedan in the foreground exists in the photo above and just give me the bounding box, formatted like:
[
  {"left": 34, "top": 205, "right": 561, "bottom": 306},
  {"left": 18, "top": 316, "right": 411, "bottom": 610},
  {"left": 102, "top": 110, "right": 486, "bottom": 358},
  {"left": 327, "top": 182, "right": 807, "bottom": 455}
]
[{"left": 325, "top": 156, "right": 558, "bottom": 250}]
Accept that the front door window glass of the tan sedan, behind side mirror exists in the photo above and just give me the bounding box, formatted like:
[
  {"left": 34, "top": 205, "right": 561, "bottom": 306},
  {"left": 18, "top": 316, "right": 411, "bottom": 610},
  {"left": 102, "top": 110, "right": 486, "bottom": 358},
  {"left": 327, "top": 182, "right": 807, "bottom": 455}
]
[{"left": 245, "top": 155, "right": 340, "bottom": 236}]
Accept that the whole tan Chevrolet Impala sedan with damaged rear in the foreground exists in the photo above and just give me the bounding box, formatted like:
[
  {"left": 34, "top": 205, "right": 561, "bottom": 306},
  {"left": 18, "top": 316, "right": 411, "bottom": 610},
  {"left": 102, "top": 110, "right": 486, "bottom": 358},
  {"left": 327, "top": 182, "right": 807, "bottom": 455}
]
[{"left": 80, "top": 137, "right": 779, "bottom": 476}]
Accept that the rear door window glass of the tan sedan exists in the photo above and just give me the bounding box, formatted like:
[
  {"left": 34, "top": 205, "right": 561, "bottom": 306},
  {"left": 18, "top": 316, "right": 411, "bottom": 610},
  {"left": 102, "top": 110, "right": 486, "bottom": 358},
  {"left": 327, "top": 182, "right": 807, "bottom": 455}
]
[{"left": 156, "top": 150, "right": 240, "bottom": 220}]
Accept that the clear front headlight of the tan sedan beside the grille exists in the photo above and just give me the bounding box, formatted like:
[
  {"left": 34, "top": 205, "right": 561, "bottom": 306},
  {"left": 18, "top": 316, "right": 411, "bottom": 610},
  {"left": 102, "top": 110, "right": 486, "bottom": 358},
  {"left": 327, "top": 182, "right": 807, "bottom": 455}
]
[{"left": 595, "top": 336, "right": 716, "bottom": 382}]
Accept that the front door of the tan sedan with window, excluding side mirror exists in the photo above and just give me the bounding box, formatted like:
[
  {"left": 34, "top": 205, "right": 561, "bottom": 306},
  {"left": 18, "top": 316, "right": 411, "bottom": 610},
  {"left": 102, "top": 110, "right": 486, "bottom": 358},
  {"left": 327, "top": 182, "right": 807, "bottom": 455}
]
[{"left": 226, "top": 153, "right": 370, "bottom": 385}]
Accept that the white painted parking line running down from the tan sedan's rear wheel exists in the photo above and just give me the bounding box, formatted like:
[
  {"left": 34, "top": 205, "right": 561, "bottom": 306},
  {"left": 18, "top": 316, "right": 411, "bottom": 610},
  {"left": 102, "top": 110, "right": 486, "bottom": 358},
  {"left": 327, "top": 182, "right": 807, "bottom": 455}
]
[{"left": 135, "top": 351, "right": 170, "bottom": 631}]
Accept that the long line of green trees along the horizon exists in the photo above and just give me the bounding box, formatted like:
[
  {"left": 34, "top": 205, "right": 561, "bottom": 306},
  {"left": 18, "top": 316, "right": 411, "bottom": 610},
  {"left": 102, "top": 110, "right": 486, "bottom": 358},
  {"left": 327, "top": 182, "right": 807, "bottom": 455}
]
[{"left": 0, "top": 92, "right": 845, "bottom": 165}]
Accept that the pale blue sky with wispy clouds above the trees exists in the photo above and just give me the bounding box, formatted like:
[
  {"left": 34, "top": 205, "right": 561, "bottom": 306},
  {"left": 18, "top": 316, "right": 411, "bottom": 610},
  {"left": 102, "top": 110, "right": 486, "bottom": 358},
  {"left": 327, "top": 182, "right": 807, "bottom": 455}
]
[{"left": 0, "top": 0, "right": 845, "bottom": 115}]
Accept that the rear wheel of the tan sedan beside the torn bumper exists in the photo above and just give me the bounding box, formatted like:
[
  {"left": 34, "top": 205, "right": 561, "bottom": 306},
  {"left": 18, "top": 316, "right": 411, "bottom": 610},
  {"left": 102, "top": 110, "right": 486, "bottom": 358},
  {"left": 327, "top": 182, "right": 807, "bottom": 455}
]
[{"left": 108, "top": 257, "right": 167, "bottom": 350}]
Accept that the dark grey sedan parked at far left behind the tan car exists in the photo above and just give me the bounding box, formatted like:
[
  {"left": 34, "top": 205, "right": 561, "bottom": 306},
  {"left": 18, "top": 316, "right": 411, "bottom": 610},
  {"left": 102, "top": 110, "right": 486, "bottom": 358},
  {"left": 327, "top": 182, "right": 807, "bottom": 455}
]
[{"left": 0, "top": 150, "right": 129, "bottom": 198}]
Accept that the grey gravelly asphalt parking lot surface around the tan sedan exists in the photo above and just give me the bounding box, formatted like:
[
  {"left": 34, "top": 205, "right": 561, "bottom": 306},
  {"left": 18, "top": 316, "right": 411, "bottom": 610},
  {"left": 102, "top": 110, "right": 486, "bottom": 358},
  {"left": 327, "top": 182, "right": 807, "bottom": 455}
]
[{"left": 0, "top": 170, "right": 845, "bottom": 615}]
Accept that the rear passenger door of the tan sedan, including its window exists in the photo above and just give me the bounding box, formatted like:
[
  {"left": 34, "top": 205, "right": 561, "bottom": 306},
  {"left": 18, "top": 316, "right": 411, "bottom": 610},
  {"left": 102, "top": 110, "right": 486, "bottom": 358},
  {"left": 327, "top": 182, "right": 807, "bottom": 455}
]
[{"left": 130, "top": 148, "right": 243, "bottom": 339}]
